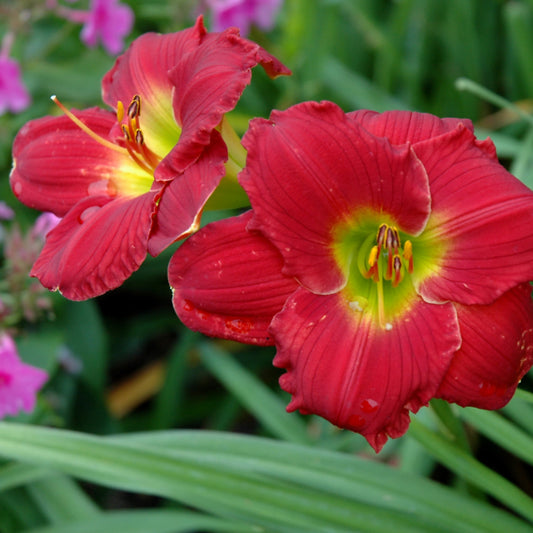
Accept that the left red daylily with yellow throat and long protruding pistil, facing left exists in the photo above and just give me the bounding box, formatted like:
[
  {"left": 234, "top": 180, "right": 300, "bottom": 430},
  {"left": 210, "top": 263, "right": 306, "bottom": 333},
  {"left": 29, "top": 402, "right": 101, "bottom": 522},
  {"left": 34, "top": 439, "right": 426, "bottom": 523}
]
[{"left": 10, "top": 17, "right": 289, "bottom": 300}]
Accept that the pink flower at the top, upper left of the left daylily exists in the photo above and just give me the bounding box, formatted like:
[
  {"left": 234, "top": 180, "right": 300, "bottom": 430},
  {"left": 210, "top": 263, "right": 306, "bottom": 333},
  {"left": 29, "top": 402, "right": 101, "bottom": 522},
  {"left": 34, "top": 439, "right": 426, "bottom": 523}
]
[{"left": 81, "top": 0, "right": 134, "bottom": 55}]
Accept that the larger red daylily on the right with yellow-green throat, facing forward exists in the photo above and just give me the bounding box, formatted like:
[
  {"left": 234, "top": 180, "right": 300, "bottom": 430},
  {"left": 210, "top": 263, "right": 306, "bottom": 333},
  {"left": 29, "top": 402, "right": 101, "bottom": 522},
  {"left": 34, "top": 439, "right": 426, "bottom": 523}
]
[{"left": 169, "top": 102, "right": 533, "bottom": 451}]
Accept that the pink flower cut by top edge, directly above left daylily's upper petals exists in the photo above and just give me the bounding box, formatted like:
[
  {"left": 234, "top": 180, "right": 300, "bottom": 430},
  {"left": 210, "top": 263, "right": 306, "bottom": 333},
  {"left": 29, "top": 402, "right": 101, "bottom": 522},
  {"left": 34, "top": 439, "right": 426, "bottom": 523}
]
[{"left": 207, "top": 0, "right": 283, "bottom": 35}]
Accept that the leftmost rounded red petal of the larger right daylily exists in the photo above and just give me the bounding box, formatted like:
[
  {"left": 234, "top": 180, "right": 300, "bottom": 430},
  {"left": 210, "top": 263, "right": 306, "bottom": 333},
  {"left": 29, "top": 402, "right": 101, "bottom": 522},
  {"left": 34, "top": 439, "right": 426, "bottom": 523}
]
[{"left": 168, "top": 211, "right": 297, "bottom": 346}]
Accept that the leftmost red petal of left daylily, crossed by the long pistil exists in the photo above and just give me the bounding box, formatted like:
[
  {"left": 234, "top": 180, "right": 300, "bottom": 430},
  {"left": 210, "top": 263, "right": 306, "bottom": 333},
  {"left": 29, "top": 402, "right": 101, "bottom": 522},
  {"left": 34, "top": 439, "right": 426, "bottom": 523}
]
[{"left": 10, "top": 108, "right": 122, "bottom": 217}]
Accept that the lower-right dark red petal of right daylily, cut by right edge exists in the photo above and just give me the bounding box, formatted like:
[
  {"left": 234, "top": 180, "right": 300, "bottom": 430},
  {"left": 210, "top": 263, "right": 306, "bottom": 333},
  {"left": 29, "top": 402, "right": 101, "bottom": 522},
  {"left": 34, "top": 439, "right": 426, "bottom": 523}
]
[{"left": 437, "top": 284, "right": 533, "bottom": 409}]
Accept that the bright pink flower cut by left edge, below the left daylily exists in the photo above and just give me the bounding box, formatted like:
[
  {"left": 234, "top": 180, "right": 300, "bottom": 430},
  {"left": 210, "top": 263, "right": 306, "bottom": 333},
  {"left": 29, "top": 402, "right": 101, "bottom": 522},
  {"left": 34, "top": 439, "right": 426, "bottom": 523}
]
[{"left": 0, "top": 333, "right": 48, "bottom": 419}]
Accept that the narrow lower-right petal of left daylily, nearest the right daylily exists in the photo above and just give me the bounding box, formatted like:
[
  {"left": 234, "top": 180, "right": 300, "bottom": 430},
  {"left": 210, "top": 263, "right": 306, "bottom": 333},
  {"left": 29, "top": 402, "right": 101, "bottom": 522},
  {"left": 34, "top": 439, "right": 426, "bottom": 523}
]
[{"left": 148, "top": 131, "right": 227, "bottom": 252}]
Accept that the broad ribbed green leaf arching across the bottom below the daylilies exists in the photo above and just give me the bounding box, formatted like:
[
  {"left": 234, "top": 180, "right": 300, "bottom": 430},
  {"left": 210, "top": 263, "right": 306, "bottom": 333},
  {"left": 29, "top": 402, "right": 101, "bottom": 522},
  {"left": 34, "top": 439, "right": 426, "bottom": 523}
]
[{"left": 0, "top": 422, "right": 530, "bottom": 533}]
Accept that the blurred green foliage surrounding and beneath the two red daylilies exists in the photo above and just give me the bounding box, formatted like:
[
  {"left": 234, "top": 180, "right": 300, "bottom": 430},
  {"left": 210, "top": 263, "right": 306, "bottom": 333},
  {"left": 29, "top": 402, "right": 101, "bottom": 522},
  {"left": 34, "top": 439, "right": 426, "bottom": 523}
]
[{"left": 0, "top": 0, "right": 533, "bottom": 533}]
